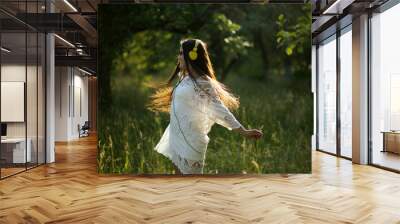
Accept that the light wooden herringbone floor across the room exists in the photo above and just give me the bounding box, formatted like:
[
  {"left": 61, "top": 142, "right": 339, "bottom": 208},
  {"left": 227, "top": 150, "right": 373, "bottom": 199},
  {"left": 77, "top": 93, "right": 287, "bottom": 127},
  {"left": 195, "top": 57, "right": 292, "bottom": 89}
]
[{"left": 0, "top": 137, "right": 400, "bottom": 224}]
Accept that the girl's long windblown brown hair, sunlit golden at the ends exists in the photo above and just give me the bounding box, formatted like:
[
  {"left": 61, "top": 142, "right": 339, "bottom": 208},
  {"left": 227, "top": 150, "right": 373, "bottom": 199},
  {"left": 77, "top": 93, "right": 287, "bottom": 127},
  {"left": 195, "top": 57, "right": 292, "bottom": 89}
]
[{"left": 147, "top": 39, "right": 239, "bottom": 112}]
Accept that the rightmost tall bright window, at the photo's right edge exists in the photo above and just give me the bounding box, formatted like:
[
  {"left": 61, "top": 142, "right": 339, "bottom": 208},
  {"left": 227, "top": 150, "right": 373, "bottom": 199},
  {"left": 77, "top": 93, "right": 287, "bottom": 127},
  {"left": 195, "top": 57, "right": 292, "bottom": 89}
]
[{"left": 370, "top": 4, "right": 400, "bottom": 170}]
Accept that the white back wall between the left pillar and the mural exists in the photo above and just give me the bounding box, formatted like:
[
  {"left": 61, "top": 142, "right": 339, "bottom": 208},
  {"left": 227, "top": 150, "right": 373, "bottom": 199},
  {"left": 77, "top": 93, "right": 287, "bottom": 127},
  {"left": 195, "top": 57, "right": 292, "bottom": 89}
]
[{"left": 55, "top": 67, "right": 88, "bottom": 141}]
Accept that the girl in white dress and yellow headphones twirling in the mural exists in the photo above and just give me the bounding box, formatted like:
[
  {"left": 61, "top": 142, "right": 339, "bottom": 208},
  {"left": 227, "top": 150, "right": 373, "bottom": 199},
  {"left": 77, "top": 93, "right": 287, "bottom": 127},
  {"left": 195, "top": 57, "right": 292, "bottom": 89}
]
[{"left": 149, "top": 39, "right": 262, "bottom": 174}]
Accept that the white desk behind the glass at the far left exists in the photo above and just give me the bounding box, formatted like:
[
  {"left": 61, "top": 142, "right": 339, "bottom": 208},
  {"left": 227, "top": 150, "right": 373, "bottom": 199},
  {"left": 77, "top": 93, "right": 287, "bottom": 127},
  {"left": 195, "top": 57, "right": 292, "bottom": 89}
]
[{"left": 1, "top": 138, "right": 32, "bottom": 163}]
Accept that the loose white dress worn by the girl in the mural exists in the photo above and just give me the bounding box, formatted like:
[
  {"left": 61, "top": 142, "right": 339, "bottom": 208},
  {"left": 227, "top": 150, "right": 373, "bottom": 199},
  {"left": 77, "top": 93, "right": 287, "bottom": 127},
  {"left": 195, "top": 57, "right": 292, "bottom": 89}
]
[{"left": 155, "top": 76, "right": 241, "bottom": 174}]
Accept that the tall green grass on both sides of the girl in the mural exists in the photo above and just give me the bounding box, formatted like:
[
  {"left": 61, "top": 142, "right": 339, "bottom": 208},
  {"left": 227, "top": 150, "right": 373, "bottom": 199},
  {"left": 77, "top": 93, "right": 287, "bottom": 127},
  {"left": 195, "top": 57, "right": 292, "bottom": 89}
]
[{"left": 98, "top": 71, "right": 312, "bottom": 174}]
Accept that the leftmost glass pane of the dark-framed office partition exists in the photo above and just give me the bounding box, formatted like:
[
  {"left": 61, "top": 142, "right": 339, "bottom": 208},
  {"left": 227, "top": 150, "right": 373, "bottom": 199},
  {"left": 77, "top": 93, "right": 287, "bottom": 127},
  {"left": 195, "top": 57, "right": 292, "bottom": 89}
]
[{"left": 0, "top": 29, "right": 27, "bottom": 177}]
